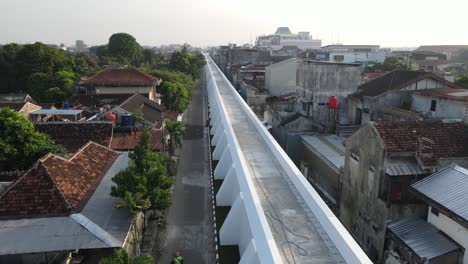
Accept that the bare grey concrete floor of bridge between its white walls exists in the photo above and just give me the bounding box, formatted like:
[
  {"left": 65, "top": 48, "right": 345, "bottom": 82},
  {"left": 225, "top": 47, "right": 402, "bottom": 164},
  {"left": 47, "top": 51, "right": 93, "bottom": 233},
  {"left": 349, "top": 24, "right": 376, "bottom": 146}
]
[{"left": 210, "top": 59, "right": 344, "bottom": 263}]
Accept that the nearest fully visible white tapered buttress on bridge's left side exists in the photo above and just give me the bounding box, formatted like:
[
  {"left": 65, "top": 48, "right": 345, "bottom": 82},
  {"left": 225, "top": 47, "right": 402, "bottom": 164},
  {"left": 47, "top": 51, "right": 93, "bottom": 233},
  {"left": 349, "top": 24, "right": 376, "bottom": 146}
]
[{"left": 219, "top": 193, "right": 245, "bottom": 245}]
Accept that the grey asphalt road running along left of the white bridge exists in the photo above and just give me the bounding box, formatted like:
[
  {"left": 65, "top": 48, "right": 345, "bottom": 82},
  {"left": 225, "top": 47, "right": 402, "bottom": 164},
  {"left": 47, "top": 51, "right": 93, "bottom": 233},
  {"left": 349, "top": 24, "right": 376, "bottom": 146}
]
[{"left": 153, "top": 75, "right": 215, "bottom": 264}]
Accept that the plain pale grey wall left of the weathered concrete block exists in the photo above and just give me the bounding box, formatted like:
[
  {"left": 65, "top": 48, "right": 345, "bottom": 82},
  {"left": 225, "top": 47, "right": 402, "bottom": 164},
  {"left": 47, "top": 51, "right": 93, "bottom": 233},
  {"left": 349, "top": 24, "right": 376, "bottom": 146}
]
[{"left": 265, "top": 58, "right": 297, "bottom": 96}]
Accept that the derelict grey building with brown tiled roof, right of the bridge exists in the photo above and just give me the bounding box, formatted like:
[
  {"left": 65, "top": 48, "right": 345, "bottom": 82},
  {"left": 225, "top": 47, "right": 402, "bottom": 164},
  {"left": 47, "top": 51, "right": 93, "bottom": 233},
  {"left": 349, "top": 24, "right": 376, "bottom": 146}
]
[{"left": 339, "top": 120, "right": 468, "bottom": 261}]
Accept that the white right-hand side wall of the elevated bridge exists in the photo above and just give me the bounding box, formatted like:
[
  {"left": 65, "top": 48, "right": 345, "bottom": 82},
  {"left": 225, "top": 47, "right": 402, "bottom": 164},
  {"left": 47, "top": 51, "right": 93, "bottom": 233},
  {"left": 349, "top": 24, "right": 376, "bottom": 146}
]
[{"left": 209, "top": 54, "right": 372, "bottom": 263}]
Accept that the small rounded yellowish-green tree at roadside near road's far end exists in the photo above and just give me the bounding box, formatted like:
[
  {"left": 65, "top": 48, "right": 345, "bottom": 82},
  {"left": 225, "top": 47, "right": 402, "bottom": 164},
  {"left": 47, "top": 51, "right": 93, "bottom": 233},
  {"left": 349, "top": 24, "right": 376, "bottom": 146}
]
[{"left": 160, "top": 81, "right": 190, "bottom": 113}]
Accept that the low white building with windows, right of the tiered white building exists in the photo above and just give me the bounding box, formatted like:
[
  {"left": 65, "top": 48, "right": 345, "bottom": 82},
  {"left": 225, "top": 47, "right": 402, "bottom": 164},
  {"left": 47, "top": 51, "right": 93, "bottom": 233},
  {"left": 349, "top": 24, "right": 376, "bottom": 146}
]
[{"left": 321, "top": 45, "right": 388, "bottom": 63}]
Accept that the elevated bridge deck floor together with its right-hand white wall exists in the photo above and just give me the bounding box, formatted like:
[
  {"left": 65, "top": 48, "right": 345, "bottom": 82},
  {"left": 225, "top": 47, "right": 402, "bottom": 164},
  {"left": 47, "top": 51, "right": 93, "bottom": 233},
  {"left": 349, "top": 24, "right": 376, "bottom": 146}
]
[{"left": 208, "top": 54, "right": 368, "bottom": 263}]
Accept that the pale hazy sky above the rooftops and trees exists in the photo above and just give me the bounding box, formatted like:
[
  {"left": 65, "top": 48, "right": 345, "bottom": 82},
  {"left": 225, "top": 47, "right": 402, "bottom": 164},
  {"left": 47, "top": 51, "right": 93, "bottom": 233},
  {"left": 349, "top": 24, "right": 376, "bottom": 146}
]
[{"left": 0, "top": 0, "right": 468, "bottom": 46}]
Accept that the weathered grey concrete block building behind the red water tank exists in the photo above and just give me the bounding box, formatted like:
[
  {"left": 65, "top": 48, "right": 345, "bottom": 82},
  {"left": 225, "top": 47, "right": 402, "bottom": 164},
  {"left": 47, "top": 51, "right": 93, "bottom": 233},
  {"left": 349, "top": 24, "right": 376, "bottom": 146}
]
[{"left": 296, "top": 59, "right": 361, "bottom": 129}]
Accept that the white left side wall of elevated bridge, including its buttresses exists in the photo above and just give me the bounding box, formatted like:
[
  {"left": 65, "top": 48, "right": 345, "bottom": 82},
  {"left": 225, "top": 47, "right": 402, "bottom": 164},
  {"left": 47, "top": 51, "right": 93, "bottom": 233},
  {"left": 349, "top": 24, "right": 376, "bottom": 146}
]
[{"left": 207, "top": 57, "right": 282, "bottom": 264}]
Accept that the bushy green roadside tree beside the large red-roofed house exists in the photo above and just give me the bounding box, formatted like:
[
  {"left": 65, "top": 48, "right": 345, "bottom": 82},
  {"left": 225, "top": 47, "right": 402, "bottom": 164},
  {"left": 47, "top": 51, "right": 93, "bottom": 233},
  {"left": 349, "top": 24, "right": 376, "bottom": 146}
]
[{"left": 111, "top": 129, "right": 173, "bottom": 211}]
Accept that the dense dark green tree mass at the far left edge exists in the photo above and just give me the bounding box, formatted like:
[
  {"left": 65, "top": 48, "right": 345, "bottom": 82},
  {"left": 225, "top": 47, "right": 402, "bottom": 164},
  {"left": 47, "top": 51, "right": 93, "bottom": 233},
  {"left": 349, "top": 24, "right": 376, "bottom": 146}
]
[{"left": 0, "top": 42, "right": 99, "bottom": 103}]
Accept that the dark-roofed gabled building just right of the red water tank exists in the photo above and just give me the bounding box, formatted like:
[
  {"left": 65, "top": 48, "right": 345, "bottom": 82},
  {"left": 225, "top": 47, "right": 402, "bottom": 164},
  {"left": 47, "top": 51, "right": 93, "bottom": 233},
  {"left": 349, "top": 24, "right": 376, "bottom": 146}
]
[{"left": 347, "top": 70, "right": 456, "bottom": 125}]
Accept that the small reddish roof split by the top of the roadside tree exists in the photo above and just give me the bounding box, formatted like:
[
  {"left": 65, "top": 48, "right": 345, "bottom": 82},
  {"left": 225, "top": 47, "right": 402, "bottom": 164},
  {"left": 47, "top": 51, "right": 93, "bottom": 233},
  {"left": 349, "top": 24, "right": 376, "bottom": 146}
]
[{"left": 110, "top": 129, "right": 165, "bottom": 151}]
